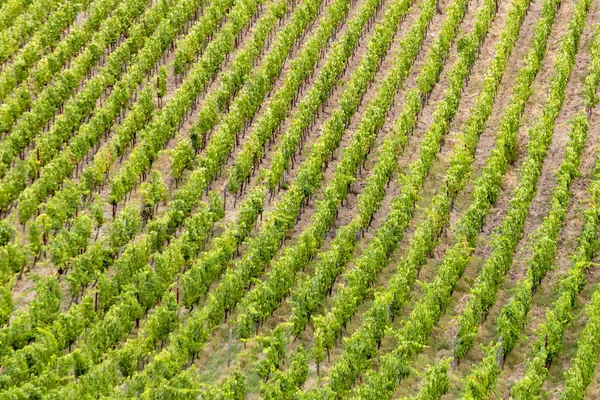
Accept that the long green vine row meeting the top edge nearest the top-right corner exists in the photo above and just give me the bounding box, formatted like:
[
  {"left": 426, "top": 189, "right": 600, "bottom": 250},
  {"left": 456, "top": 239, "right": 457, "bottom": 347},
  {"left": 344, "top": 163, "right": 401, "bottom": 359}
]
[{"left": 455, "top": 0, "right": 589, "bottom": 360}]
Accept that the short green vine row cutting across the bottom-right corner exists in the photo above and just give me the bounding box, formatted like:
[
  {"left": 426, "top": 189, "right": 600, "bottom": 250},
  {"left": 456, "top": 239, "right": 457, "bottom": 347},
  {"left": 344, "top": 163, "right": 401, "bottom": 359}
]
[{"left": 561, "top": 291, "right": 600, "bottom": 400}]
